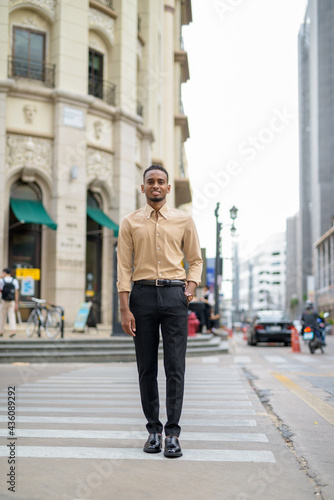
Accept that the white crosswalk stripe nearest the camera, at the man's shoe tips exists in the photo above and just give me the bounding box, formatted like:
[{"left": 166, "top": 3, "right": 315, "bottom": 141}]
[{"left": 0, "top": 446, "right": 276, "bottom": 463}]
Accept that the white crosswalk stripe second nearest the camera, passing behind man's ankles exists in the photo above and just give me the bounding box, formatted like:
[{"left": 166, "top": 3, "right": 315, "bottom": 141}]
[{"left": 0, "top": 429, "right": 268, "bottom": 446}]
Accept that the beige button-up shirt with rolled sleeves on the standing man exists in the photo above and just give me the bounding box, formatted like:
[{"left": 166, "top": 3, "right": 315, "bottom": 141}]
[{"left": 117, "top": 204, "right": 203, "bottom": 292}]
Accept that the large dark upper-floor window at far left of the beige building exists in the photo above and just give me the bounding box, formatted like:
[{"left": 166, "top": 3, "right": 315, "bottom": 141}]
[{"left": 12, "top": 28, "right": 45, "bottom": 81}]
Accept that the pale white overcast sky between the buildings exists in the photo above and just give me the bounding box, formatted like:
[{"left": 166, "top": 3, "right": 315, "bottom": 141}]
[{"left": 182, "top": 0, "right": 307, "bottom": 257}]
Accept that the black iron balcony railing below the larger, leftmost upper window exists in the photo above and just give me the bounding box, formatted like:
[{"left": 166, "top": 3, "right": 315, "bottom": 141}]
[{"left": 8, "top": 57, "right": 55, "bottom": 87}]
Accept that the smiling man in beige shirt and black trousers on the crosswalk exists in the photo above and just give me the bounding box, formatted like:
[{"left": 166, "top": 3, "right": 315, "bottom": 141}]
[{"left": 117, "top": 165, "right": 202, "bottom": 458}]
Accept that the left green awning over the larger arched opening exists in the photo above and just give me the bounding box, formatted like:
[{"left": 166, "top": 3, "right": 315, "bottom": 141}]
[{"left": 10, "top": 198, "right": 57, "bottom": 230}]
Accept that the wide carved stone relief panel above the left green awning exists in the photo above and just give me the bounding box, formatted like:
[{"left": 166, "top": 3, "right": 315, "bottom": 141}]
[{"left": 6, "top": 134, "right": 53, "bottom": 174}]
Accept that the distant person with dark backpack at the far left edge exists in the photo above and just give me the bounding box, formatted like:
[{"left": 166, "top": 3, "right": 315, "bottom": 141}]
[{"left": 0, "top": 267, "right": 19, "bottom": 337}]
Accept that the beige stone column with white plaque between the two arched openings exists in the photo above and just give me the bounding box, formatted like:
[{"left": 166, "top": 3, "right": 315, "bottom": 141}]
[{"left": 47, "top": 95, "right": 90, "bottom": 323}]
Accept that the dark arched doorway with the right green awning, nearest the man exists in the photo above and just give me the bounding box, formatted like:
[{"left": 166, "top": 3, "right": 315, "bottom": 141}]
[{"left": 86, "top": 191, "right": 102, "bottom": 323}]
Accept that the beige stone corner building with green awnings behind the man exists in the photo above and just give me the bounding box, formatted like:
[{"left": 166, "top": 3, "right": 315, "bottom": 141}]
[{"left": 0, "top": 0, "right": 192, "bottom": 324}]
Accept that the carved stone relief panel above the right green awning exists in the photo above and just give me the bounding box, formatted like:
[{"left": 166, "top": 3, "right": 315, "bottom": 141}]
[{"left": 87, "top": 147, "right": 113, "bottom": 190}]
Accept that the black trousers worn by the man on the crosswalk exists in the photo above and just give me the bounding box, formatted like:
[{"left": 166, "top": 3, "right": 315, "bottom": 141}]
[{"left": 130, "top": 285, "right": 188, "bottom": 436}]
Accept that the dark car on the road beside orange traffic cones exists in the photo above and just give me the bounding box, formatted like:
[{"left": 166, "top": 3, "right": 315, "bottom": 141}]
[{"left": 247, "top": 311, "right": 294, "bottom": 345}]
